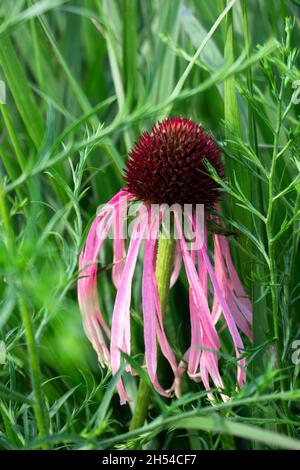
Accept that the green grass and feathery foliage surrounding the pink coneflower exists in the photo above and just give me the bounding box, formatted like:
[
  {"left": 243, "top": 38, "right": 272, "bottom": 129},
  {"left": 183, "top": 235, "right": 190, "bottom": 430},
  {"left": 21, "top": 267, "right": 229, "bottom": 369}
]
[{"left": 0, "top": 0, "right": 300, "bottom": 450}]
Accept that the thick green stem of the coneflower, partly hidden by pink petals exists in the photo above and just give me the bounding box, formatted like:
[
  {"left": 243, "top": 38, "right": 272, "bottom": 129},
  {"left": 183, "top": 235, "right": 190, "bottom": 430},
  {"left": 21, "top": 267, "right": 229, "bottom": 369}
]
[{"left": 129, "top": 236, "right": 176, "bottom": 431}]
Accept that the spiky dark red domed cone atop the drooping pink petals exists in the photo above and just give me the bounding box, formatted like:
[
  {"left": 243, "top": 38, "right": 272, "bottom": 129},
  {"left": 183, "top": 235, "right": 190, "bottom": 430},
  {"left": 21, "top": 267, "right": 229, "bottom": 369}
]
[{"left": 125, "top": 118, "right": 223, "bottom": 207}]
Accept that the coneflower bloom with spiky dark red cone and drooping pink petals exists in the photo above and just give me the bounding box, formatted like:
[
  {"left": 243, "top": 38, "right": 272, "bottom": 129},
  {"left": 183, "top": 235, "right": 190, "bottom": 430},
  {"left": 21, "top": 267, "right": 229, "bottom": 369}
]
[{"left": 78, "top": 118, "right": 252, "bottom": 403}]
